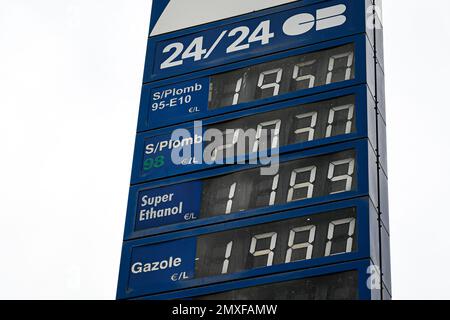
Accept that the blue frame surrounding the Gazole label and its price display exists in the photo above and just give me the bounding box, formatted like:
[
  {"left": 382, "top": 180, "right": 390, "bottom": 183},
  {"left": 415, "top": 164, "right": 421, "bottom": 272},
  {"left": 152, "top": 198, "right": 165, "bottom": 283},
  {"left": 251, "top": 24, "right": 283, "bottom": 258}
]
[{"left": 118, "top": 197, "right": 379, "bottom": 299}]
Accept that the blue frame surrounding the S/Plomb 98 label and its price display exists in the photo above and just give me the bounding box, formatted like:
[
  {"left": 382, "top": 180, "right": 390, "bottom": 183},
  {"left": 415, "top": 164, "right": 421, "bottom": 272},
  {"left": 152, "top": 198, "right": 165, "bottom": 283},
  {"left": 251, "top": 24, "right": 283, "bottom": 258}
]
[{"left": 131, "top": 85, "right": 376, "bottom": 184}]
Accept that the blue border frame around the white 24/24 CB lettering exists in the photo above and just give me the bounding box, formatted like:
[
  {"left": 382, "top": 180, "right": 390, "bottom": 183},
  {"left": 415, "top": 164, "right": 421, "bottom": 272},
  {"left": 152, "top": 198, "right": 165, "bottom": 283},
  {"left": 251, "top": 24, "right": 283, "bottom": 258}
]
[{"left": 144, "top": 0, "right": 371, "bottom": 83}]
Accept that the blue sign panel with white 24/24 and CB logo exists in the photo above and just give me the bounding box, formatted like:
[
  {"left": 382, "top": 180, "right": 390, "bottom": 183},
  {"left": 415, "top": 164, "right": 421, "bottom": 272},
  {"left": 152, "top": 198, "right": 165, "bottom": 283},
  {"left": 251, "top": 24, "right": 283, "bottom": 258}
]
[{"left": 144, "top": 0, "right": 366, "bottom": 82}]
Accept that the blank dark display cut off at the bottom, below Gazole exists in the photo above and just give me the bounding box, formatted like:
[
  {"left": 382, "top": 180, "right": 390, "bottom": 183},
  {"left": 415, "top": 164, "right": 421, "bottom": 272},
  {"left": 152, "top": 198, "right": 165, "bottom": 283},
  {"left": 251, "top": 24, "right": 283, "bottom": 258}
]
[{"left": 194, "top": 271, "right": 358, "bottom": 300}]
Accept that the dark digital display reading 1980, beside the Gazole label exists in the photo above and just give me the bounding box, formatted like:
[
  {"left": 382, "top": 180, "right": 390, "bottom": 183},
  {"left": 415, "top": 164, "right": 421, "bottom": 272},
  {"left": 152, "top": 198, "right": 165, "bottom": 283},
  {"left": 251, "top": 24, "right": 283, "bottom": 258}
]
[{"left": 195, "top": 208, "right": 357, "bottom": 278}]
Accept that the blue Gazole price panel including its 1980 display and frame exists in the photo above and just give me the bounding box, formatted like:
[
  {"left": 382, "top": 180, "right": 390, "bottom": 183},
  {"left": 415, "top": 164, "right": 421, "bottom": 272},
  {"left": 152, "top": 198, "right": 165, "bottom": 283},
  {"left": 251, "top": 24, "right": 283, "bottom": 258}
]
[{"left": 121, "top": 198, "right": 379, "bottom": 298}]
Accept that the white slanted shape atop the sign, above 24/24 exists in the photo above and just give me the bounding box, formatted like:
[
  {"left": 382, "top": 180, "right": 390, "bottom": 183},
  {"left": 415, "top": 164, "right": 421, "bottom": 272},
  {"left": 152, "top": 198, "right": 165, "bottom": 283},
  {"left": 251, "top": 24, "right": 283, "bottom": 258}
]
[{"left": 150, "top": 0, "right": 297, "bottom": 36}]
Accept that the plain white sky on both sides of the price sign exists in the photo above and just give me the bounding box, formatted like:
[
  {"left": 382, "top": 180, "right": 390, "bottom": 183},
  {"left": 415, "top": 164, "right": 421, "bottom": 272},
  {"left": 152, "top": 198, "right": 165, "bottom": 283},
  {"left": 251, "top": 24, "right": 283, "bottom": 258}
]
[{"left": 0, "top": 0, "right": 450, "bottom": 299}]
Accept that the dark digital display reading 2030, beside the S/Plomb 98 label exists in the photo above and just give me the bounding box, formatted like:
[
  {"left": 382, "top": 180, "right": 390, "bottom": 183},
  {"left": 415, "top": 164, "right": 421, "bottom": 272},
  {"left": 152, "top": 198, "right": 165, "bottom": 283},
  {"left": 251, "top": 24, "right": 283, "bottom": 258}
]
[{"left": 207, "top": 96, "right": 356, "bottom": 154}]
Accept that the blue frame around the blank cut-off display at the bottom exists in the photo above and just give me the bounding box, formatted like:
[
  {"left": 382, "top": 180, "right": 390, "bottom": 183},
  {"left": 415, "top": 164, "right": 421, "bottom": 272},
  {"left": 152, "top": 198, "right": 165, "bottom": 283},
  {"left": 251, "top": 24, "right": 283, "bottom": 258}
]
[{"left": 133, "top": 259, "right": 380, "bottom": 300}]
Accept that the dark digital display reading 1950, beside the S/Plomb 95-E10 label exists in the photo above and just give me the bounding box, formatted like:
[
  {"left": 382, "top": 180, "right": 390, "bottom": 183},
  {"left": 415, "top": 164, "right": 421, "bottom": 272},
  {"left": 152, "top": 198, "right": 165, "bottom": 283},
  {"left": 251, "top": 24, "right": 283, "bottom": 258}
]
[{"left": 208, "top": 44, "right": 355, "bottom": 109}]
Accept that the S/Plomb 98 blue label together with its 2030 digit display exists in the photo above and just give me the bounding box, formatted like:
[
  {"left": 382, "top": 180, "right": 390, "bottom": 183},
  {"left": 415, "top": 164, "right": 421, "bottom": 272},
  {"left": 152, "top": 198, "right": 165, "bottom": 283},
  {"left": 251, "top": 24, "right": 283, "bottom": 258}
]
[{"left": 132, "top": 95, "right": 356, "bottom": 183}]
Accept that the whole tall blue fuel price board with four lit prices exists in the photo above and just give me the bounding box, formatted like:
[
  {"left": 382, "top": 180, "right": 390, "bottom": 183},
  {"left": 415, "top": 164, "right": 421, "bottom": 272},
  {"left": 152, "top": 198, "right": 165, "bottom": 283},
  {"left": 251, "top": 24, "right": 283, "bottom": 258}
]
[{"left": 117, "top": 0, "right": 392, "bottom": 300}]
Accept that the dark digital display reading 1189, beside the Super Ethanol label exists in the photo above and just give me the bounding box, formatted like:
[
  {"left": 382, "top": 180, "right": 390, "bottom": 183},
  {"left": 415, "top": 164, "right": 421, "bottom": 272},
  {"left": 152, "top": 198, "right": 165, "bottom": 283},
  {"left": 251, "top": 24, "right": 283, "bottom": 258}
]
[{"left": 201, "top": 150, "right": 356, "bottom": 217}]
